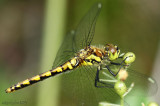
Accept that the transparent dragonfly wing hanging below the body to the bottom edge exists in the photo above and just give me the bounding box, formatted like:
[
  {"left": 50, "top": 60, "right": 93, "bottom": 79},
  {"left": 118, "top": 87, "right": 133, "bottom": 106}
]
[{"left": 57, "top": 66, "right": 128, "bottom": 106}]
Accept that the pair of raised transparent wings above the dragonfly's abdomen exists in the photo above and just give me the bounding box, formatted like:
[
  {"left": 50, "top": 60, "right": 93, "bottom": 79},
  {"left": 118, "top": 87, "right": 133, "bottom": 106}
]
[{"left": 52, "top": 3, "right": 101, "bottom": 68}]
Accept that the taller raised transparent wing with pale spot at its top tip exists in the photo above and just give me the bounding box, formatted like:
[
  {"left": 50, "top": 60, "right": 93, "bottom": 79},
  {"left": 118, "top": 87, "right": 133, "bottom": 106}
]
[{"left": 74, "top": 3, "right": 101, "bottom": 51}]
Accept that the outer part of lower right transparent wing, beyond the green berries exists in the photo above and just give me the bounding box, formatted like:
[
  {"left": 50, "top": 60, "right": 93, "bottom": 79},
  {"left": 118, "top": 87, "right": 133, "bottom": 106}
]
[{"left": 125, "top": 69, "right": 158, "bottom": 96}]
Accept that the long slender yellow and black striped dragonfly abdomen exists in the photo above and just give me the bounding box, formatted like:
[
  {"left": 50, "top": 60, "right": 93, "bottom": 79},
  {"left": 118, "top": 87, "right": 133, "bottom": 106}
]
[{"left": 6, "top": 57, "right": 79, "bottom": 93}]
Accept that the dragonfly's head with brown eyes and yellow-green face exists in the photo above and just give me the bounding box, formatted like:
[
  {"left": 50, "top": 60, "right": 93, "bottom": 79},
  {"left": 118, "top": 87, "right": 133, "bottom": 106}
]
[{"left": 105, "top": 44, "right": 120, "bottom": 60}]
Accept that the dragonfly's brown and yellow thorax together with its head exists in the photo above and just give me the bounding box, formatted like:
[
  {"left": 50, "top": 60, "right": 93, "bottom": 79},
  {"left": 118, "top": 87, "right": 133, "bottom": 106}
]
[{"left": 76, "top": 44, "right": 120, "bottom": 65}]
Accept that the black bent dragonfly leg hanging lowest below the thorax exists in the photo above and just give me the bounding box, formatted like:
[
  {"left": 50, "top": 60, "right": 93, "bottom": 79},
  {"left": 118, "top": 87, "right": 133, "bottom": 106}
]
[{"left": 95, "top": 66, "right": 114, "bottom": 88}]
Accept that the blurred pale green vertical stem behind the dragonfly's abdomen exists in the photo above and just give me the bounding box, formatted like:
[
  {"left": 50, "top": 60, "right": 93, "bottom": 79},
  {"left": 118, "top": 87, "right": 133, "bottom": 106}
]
[{"left": 37, "top": 0, "right": 67, "bottom": 106}]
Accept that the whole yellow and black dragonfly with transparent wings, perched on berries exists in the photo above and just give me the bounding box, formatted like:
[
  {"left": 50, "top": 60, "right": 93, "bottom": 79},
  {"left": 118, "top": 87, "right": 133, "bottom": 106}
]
[{"left": 5, "top": 3, "right": 157, "bottom": 106}]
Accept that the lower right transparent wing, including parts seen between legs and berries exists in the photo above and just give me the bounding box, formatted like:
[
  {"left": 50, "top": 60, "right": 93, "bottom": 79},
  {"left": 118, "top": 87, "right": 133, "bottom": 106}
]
[{"left": 100, "top": 65, "right": 158, "bottom": 96}]
